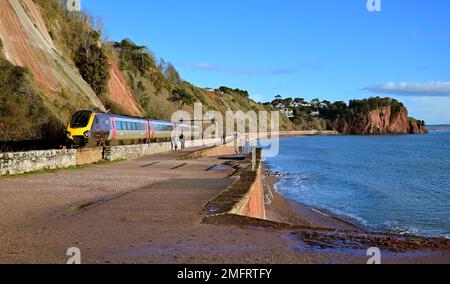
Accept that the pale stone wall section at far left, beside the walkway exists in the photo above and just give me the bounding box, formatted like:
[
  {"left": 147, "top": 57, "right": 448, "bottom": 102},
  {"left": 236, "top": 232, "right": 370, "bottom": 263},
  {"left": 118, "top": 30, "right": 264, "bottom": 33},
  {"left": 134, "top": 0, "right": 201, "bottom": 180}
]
[{"left": 0, "top": 150, "right": 77, "bottom": 176}]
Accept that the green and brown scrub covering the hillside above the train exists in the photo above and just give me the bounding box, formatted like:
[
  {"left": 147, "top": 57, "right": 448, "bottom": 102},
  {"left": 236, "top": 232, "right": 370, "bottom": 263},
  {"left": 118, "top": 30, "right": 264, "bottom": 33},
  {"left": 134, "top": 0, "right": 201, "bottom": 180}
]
[{"left": 0, "top": 0, "right": 293, "bottom": 149}]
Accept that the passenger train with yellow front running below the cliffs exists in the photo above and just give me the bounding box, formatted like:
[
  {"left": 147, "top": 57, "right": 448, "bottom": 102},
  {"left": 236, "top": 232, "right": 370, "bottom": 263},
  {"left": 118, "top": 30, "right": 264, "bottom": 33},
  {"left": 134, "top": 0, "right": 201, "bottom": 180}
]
[{"left": 65, "top": 110, "right": 199, "bottom": 148}]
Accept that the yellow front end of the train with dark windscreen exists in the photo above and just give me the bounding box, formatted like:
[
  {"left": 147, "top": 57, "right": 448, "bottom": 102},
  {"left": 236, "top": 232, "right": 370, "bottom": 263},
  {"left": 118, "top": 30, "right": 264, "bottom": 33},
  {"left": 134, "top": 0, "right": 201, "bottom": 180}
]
[{"left": 66, "top": 111, "right": 95, "bottom": 147}]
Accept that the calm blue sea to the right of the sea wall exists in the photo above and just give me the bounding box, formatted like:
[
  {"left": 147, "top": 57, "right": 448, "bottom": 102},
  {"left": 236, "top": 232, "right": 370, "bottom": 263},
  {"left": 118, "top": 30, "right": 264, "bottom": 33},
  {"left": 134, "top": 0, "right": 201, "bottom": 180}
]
[{"left": 266, "top": 131, "right": 450, "bottom": 238}]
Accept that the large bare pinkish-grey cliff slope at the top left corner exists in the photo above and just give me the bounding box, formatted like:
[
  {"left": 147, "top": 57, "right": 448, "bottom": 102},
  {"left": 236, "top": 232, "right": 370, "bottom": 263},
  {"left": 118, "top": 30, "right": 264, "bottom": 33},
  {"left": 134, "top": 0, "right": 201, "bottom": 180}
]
[{"left": 0, "top": 0, "right": 104, "bottom": 110}]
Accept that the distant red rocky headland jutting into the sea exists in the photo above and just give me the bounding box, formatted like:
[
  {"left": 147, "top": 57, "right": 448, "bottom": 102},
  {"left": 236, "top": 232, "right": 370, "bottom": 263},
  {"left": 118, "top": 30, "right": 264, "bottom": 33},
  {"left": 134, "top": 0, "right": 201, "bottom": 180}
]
[{"left": 335, "top": 106, "right": 428, "bottom": 135}]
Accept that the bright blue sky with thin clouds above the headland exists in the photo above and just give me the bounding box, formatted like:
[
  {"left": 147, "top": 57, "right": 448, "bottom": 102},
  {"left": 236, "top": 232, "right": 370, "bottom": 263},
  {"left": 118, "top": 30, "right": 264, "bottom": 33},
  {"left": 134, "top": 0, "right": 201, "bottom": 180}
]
[{"left": 81, "top": 0, "right": 450, "bottom": 124}]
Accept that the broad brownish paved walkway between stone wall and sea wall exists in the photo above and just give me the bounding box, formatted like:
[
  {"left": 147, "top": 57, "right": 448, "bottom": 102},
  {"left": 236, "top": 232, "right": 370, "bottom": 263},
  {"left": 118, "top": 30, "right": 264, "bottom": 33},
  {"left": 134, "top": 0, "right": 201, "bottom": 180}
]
[{"left": 0, "top": 150, "right": 298, "bottom": 263}]
